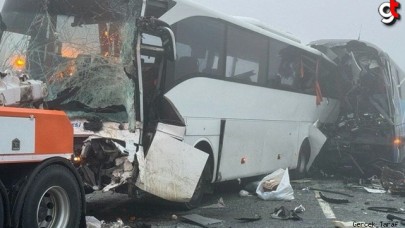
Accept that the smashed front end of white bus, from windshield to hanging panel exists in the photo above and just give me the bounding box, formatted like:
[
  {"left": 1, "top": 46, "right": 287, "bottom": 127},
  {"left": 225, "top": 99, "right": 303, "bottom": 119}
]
[{"left": 0, "top": 0, "right": 207, "bottom": 202}]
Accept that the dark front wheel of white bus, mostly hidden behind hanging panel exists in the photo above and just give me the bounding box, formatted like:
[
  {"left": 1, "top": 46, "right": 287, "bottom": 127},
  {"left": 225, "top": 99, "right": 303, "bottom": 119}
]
[{"left": 182, "top": 159, "right": 211, "bottom": 210}]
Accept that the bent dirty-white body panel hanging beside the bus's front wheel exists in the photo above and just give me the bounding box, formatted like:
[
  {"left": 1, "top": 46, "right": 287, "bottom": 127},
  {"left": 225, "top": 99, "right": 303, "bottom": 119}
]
[{"left": 136, "top": 129, "right": 208, "bottom": 202}]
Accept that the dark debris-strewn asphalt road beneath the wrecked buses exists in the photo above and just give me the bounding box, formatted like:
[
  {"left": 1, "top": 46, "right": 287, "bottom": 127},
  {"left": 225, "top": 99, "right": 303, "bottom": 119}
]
[{"left": 87, "top": 179, "right": 405, "bottom": 227}]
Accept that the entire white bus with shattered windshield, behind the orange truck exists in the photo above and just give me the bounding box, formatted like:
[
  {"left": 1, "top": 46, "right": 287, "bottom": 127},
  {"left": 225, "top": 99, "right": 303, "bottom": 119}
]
[{"left": 0, "top": 0, "right": 339, "bottom": 207}]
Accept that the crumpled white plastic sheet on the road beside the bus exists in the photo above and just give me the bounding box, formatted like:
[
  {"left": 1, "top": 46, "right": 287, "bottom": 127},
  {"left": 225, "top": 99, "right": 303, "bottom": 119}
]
[{"left": 256, "top": 169, "right": 294, "bottom": 200}]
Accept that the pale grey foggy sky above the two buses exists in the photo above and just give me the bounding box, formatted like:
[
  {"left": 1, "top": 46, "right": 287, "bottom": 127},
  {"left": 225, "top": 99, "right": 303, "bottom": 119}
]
[{"left": 0, "top": 0, "right": 405, "bottom": 70}]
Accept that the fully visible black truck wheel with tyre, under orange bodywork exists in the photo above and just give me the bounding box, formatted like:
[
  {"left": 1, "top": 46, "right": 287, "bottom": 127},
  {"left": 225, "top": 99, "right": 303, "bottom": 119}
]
[{"left": 21, "top": 165, "right": 82, "bottom": 228}]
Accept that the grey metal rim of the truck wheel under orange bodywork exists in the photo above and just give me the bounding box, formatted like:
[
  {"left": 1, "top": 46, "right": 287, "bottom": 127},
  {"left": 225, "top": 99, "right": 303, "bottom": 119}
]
[{"left": 37, "top": 186, "right": 70, "bottom": 228}]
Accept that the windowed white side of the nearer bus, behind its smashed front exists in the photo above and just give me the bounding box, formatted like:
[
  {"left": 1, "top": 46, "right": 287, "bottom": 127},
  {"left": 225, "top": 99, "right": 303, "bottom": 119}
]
[{"left": 152, "top": 1, "right": 339, "bottom": 181}]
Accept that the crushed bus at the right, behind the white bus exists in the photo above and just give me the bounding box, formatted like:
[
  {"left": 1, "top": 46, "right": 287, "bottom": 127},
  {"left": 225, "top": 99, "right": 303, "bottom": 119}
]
[{"left": 311, "top": 40, "right": 405, "bottom": 174}]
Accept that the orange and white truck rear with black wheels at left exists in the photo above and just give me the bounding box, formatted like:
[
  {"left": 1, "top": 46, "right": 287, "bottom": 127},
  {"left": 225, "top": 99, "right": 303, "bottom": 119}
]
[{"left": 0, "top": 107, "right": 85, "bottom": 228}]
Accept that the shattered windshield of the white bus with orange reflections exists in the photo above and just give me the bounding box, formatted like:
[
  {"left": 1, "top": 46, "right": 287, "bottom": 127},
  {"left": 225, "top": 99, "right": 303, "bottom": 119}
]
[{"left": 0, "top": 0, "right": 140, "bottom": 128}]
